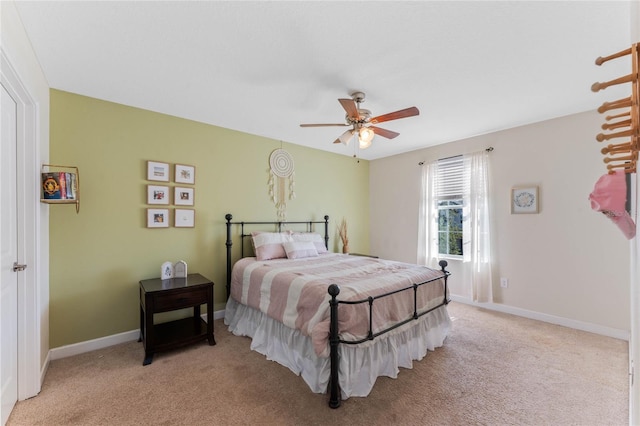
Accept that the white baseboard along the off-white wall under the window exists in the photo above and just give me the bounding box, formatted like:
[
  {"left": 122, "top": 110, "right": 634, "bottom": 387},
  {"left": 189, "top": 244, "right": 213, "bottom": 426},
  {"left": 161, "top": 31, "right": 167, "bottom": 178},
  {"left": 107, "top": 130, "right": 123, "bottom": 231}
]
[{"left": 450, "top": 294, "right": 631, "bottom": 342}]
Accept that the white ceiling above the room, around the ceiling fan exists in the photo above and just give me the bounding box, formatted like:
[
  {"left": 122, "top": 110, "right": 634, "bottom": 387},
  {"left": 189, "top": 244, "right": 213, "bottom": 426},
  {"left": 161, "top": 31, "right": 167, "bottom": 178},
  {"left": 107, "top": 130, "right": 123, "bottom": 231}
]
[{"left": 16, "top": 1, "right": 631, "bottom": 159}]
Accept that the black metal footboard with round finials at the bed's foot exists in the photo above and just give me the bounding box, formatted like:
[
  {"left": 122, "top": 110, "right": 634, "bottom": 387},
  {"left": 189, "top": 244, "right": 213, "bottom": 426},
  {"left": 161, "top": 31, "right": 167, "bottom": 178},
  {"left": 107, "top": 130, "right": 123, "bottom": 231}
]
[{"left": 328, "top": 260, "right": 450, "bottom": 408}]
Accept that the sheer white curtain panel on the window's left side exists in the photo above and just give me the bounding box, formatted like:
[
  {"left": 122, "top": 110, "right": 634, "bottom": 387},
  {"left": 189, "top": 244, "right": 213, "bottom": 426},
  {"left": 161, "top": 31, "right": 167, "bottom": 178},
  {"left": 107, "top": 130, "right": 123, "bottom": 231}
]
[{"left": 418, "top": 161, "right": 438, "bottom": 268}]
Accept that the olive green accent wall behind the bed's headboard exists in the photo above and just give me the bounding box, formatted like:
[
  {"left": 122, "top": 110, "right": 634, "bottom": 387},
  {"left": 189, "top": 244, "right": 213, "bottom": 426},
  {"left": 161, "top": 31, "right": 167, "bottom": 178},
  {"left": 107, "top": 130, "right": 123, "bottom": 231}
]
[{"left": 49, "top": 90, "right": 369, "bottom": 348}]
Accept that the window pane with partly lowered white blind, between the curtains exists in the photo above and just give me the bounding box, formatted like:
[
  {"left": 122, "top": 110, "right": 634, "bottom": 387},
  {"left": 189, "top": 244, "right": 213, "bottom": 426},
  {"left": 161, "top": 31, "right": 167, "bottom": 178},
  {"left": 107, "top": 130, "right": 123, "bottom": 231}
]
[{"left": 435, "top": 156, "right": 464, "bottom": 257}]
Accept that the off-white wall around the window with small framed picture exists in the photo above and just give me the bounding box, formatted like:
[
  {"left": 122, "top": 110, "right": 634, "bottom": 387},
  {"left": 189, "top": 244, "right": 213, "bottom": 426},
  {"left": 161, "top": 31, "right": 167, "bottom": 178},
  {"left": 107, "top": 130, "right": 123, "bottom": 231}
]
[{"left": 370, "top": 110, "right": 630, "bottom": 332}]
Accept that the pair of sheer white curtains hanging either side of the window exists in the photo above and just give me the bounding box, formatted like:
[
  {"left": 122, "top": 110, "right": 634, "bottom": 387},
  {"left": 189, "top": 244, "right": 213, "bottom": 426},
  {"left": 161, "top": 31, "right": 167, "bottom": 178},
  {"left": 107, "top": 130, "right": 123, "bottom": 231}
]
[{"left": 418, "top": 151, "right": 493, "bottom": 303}]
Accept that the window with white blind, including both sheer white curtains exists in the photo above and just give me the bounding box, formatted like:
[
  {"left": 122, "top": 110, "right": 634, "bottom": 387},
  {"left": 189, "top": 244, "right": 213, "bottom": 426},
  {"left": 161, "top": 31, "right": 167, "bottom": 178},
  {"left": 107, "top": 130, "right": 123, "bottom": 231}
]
[{"left": 417, "top": 148, "right": 493, "bottom": 302}]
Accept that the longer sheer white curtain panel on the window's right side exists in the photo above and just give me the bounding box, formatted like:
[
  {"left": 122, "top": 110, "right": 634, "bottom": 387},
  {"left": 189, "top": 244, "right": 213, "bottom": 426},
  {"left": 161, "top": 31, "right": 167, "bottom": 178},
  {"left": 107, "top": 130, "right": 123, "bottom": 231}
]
[{"left": 462, "top": 151, "right": 493, "bottom": 302}]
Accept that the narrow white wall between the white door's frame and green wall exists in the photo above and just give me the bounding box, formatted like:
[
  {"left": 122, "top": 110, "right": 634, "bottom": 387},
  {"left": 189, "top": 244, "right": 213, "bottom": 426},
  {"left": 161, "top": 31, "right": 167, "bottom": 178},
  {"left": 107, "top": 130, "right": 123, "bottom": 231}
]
[{"left": 0, "top": 1, "right": 49, "bottom": 392}]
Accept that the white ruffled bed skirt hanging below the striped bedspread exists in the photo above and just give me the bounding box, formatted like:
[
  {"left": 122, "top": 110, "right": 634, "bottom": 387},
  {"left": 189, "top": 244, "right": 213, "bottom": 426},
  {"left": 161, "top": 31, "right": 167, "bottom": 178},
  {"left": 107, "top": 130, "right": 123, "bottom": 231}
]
[{"left": 224, "top": 298, "right": 451, "bottom": 399}]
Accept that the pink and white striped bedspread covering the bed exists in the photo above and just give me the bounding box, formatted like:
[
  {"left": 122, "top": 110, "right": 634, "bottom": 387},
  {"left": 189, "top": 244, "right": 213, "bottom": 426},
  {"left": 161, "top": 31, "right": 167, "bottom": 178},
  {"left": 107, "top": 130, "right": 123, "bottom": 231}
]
[{"left": 231, "top": 253, "right": 444, "bottom": 357}]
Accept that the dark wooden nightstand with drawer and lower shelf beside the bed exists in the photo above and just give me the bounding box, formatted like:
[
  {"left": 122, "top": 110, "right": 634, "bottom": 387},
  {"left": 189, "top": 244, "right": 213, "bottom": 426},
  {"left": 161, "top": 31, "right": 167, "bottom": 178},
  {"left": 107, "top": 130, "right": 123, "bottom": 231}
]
[{"left": 138, "top": 274, "right": 216, "bottom": 365}]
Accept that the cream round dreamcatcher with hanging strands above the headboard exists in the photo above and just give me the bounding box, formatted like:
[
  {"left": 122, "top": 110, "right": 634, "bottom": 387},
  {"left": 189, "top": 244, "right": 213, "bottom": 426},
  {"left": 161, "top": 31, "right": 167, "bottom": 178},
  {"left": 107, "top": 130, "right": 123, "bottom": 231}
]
[{"left": 269, "top": 149, "right": 296, "bottom": 221}]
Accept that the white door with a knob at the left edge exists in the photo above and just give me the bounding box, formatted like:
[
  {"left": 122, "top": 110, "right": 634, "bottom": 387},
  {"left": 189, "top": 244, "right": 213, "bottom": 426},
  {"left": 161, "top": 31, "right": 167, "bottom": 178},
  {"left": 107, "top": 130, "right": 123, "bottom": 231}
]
[{"left": 0, "top": 80, "right": 19, "bottom": 425}]
